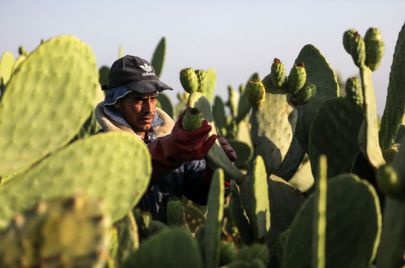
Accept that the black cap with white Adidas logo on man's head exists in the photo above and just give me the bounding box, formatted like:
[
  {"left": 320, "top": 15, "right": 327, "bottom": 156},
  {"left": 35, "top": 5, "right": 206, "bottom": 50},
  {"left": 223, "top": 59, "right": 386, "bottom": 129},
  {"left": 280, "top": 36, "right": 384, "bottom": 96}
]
[{"left": 103, "top": 55, "right": 173, "bottom": 94}]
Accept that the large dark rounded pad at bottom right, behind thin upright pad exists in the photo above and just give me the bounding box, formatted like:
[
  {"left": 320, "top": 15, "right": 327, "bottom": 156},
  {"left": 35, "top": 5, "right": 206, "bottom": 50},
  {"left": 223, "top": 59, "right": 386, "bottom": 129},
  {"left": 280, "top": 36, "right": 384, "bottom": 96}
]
[{"left": 282, "top": 174, "right": 381, "bottom": 268}]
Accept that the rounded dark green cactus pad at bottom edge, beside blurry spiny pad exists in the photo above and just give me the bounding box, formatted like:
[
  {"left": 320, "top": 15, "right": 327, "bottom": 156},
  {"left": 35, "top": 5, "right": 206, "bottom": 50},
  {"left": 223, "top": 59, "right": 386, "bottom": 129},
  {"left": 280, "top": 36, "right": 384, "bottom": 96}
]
[{"left": 123, "top": 227, "right": 203, "bottom": 268}]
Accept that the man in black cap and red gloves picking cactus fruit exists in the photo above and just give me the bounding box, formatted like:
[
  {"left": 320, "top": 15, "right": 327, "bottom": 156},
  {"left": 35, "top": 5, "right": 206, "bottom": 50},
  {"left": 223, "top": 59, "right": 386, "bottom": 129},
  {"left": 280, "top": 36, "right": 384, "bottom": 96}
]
[{"left": 96, "top": 55, "right": 236, "bottom": 221}]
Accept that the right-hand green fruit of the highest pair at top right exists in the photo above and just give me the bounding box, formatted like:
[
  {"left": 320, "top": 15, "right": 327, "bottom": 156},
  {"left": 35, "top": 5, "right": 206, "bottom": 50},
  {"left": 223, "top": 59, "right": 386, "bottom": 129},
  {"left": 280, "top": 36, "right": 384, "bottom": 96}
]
[{"left": 364, "top": 28, "right": 384, "bottom": 71}]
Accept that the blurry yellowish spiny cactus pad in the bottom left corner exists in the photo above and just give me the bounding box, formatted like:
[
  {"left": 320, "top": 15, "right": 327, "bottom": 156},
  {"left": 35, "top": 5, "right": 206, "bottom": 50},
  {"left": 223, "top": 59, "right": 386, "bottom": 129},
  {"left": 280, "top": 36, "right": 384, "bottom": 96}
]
[{"left": 0, "top": 196, "right": 110, "bottom": 267}]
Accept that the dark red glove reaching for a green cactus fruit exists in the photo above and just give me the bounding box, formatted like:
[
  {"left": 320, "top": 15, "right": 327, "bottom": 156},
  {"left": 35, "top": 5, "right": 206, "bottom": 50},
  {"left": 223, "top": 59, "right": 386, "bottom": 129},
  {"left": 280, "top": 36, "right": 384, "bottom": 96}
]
[{"left": 148, "top": 113, "right": 217, "bottom": 179}]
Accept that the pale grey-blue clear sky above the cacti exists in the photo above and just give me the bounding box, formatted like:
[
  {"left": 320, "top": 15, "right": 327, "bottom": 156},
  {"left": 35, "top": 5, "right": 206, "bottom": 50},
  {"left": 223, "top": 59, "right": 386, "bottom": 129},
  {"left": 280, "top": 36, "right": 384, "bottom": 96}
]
[{"left": 0, "top": 0, "right": 405, "bottom": 114}]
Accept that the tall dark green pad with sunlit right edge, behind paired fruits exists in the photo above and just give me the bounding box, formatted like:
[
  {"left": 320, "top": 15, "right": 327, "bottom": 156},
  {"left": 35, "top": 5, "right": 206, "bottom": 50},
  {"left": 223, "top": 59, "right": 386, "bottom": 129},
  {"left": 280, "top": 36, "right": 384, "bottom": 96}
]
[{"left": 295, "top": 45, "right": 339, "bottom": 152}]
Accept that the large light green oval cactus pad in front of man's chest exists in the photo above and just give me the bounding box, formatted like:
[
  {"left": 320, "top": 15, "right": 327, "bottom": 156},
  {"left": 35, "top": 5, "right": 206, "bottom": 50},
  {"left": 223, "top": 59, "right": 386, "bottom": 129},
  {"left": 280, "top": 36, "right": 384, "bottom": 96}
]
[{"left": 0, "top": 133, "right": 151, "bottom": 227}]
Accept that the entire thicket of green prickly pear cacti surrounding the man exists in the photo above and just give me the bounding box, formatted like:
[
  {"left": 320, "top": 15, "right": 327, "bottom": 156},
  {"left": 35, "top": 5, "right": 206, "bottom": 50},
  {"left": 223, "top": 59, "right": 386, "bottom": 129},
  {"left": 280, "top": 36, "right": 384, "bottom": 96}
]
[{"left": 0, "top": 21, "right": 405, "bottom": 268}]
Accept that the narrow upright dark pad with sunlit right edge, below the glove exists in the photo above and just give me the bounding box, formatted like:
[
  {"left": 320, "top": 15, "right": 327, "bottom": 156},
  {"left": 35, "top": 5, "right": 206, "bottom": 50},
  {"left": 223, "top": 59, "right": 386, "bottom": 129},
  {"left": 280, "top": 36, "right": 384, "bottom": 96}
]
[{"left": 204, "top": 169, "right": 225, "bottom": 268}]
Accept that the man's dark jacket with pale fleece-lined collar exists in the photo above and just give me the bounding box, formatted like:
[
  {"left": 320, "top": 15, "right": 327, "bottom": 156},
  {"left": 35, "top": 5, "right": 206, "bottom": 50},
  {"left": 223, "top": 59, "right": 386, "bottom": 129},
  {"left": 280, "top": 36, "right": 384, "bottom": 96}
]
[{"left": 96, "top": 103, "right": 210, "bottom": 222}]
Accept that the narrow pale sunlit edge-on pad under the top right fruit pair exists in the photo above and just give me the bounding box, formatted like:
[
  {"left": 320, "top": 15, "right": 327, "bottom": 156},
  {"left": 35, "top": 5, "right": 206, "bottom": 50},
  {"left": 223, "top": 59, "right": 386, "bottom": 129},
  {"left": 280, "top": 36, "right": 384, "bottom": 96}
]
[{"left": 358, "top": 66, "right": 385, "bottom": 169}]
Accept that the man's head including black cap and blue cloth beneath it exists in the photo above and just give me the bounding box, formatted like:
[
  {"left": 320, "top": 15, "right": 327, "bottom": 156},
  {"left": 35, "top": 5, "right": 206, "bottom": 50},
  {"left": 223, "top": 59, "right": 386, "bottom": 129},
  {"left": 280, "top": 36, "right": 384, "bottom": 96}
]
[{"left": 104, "top": 55, "right": 172, "bottom": 131}]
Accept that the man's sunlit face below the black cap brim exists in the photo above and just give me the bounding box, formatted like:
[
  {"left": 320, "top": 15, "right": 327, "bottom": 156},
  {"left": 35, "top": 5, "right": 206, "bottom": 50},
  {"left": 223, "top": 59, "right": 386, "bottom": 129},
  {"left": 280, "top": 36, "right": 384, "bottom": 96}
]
[{"left": 116, "top": 92, "right": 157, "bottom": 131}]
